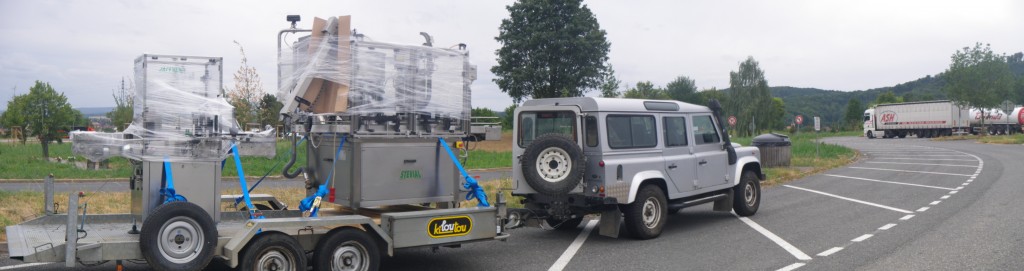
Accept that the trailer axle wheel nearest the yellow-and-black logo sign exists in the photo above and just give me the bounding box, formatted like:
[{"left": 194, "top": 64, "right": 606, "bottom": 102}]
[{"left": 313, "top": 228, "right": 381, "bottom": 271}]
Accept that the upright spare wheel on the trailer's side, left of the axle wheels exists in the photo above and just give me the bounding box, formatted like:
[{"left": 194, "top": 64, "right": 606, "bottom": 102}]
[{"left": 138, "top": 201, "right": 217, "bottom": 271}]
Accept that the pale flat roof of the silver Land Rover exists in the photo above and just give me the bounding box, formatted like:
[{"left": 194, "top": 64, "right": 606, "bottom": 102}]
[{"left": 522, "top": 97, "right": 711, "bottom": 112}]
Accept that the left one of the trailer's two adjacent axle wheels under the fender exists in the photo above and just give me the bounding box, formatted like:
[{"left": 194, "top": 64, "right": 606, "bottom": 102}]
[{"left": 239, "top": 232, "right": 306, "bottom": 271}]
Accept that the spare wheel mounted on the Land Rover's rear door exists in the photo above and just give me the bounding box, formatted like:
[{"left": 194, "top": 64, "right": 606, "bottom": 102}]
[{"left": 521, "top": 134, "right": 586, "bottom": 195}]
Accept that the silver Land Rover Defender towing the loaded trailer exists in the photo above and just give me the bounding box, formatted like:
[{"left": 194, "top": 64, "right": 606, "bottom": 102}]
[{"left": 509, "top": 97, "right": 765, "bottom": 239}]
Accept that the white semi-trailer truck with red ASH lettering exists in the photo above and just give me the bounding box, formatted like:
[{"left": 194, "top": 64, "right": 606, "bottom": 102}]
[{"left": 864, "top": 100, "right": 972, "bottom": 138}]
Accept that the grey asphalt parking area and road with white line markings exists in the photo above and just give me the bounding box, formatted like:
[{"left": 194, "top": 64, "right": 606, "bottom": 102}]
[{"left": 0, "top": 138, "right": 1024, "bottom": 271}]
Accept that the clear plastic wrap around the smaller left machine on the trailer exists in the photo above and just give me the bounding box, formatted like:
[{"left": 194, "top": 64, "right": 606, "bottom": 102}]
[{"left": 72, "top": 54, "right": 275, "bottom": 161}]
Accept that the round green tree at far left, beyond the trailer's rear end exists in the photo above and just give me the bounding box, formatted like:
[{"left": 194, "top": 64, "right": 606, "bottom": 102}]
[{"left": 18, "top": 81, "right": 82, "bottom": 159}]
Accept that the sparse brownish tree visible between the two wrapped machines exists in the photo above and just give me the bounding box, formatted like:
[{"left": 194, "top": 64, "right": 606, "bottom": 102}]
[{"left": 227, "top": 41, "right": 263, "bottom": 127}]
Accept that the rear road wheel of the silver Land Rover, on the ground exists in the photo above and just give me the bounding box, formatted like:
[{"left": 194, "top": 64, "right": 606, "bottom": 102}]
[{"left": 623, "top": 184, "right": 669, "bottom": 239}]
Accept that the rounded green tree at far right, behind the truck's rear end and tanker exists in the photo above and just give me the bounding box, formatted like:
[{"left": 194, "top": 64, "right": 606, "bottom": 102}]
[{"left": 942, "top": 42, "right": 1014, "bottom": 130}]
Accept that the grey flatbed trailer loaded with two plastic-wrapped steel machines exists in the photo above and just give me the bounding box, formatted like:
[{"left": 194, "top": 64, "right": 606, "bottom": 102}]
[{"left": 7, "top": 15, "right": 509, "bottom": 270}]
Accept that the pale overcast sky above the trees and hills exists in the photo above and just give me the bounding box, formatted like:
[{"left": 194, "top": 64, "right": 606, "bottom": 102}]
[{"left": 0, "top": 0, "right": 1024, "bottom": 110}]
